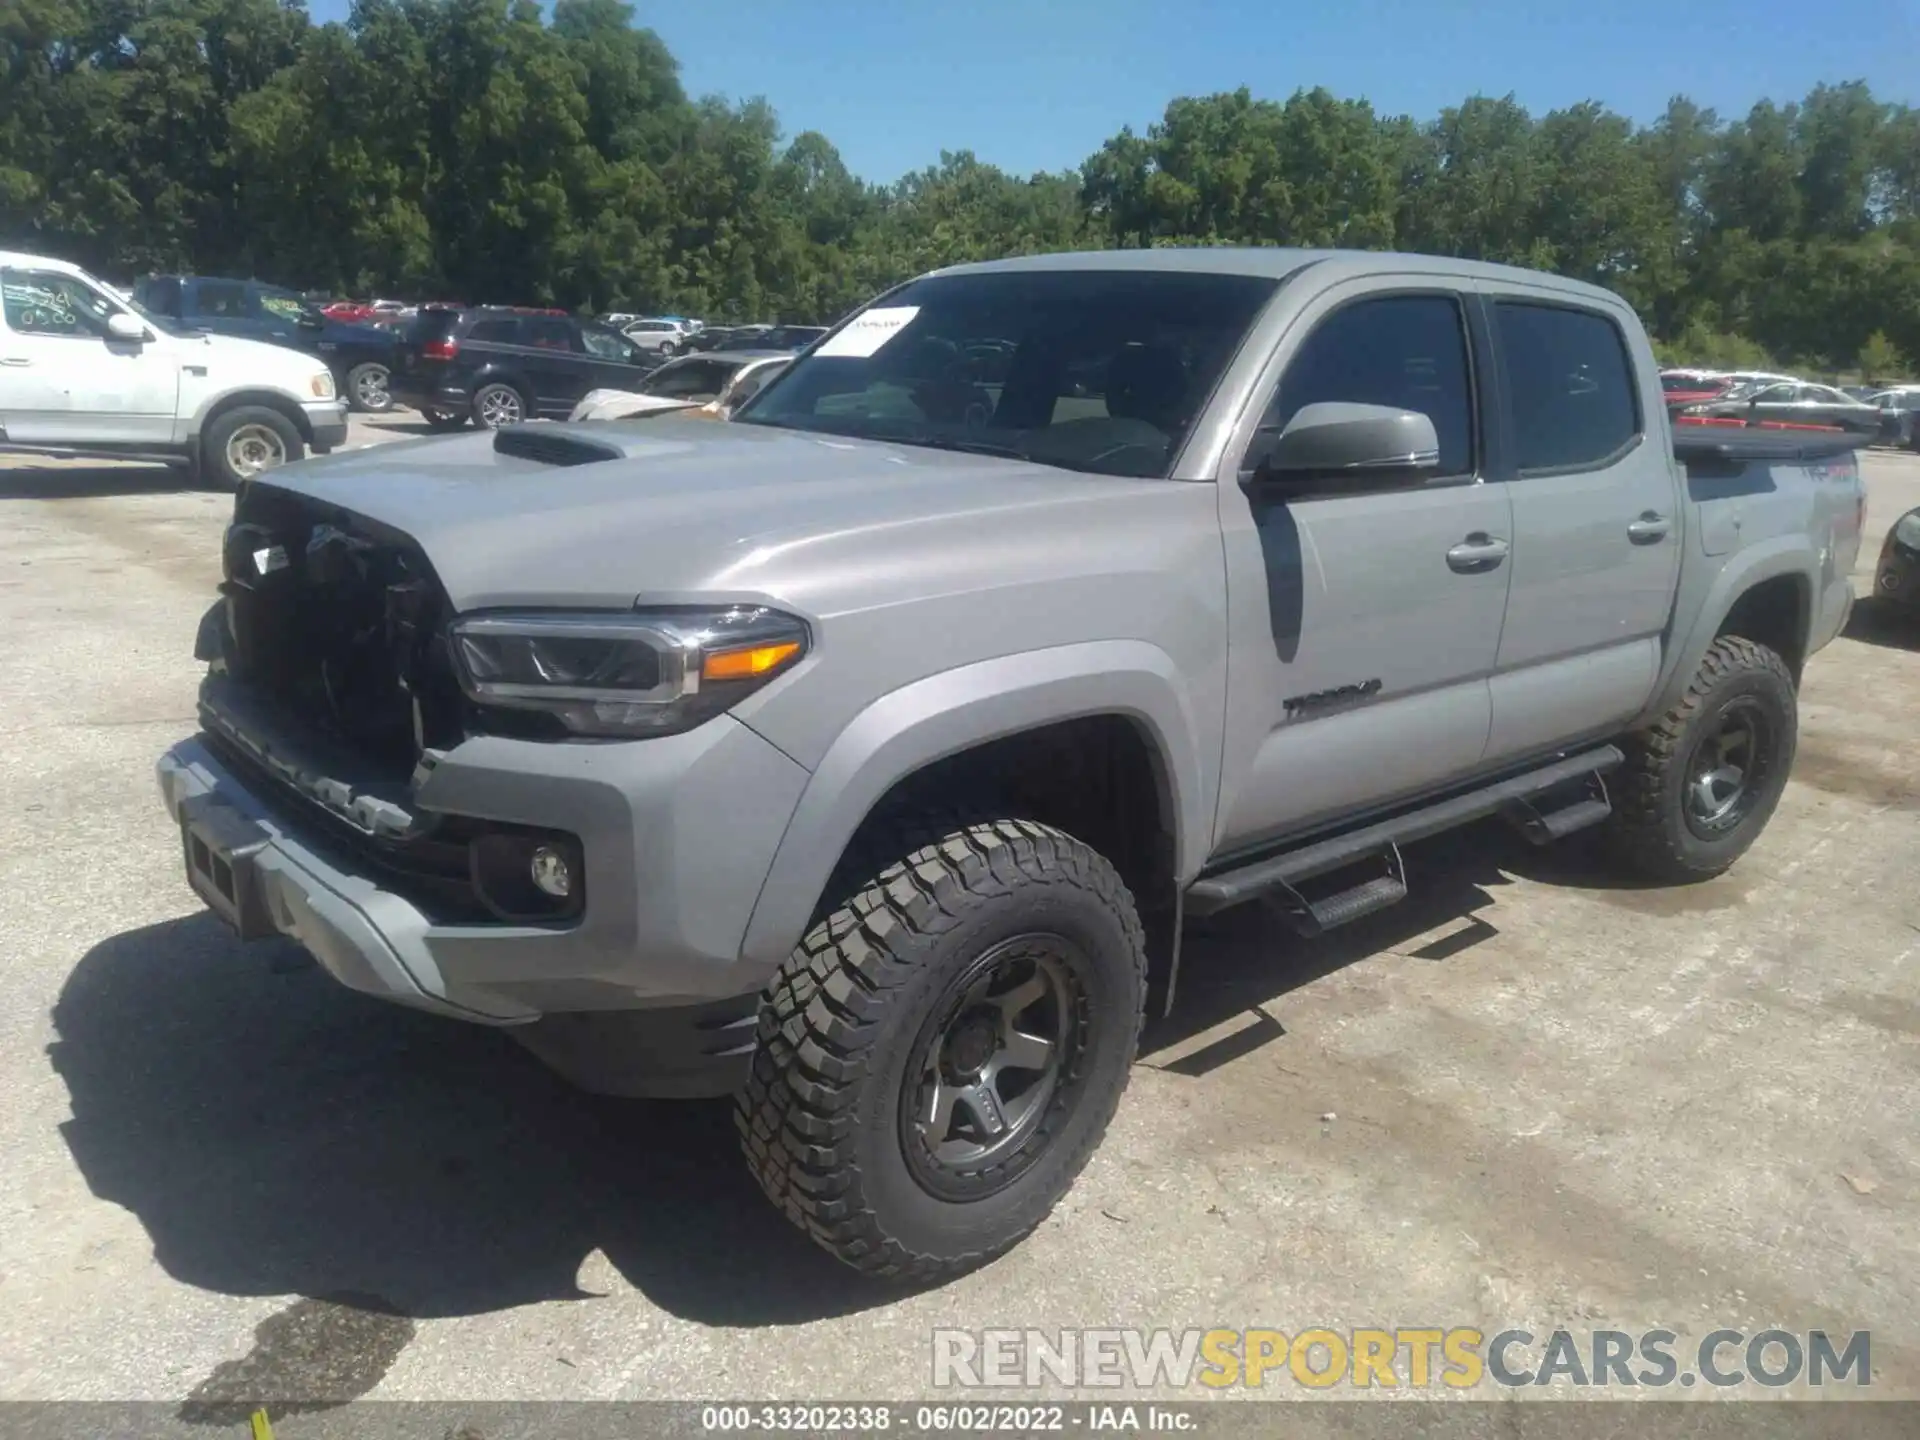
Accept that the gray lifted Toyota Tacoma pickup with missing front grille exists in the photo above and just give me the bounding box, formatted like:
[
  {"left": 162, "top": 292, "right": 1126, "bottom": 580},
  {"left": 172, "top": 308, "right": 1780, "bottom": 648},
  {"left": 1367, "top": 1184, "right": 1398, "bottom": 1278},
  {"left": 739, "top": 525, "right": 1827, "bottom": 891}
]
[{"left": 159, "top": 250, "right": 1864, "bottom": 1279}]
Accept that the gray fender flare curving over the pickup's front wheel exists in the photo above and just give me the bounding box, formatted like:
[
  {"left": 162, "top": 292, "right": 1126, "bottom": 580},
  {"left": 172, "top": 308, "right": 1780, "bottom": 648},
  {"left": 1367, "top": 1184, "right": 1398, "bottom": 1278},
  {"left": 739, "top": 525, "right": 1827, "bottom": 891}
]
[{"left": 741, "top": 639, "right": 1212, "bottom": 966}]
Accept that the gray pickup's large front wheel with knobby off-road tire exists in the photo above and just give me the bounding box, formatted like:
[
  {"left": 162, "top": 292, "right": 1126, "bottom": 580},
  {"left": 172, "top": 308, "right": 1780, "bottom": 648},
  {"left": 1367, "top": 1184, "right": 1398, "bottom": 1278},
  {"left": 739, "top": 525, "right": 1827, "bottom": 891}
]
[{"left": 735, "top": 820, "right": 1146, "bottom": 1281}]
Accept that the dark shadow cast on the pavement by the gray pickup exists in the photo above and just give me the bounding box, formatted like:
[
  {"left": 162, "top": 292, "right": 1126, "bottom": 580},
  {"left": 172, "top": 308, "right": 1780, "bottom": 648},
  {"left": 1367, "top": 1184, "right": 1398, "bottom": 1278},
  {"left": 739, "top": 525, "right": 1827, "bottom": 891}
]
[{"left": 50, "top": 826, "right": 1651, "bottom": 1327}]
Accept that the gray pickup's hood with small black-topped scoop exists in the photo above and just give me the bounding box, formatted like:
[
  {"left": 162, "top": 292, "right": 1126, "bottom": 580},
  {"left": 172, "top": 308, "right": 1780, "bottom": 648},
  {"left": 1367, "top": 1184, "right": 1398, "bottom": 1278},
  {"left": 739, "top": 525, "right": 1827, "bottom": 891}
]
[{"left": 253, "top": 415, "right": 1182, "bottom": 614}]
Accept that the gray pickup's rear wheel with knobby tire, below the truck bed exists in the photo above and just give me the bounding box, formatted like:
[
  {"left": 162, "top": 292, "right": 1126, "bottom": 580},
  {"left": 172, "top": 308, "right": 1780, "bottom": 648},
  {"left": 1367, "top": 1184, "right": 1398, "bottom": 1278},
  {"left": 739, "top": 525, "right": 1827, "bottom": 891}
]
[{"left": 1607, "top": 636, "right": 1799, "bottom": 883}]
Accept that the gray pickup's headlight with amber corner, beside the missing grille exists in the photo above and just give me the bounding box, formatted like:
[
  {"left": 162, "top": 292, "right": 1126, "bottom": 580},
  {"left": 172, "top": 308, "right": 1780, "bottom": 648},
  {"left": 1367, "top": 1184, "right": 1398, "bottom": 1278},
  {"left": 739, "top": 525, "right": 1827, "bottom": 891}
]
[{"left": 449, "top": 607, "right": 808, "bottom": 739}]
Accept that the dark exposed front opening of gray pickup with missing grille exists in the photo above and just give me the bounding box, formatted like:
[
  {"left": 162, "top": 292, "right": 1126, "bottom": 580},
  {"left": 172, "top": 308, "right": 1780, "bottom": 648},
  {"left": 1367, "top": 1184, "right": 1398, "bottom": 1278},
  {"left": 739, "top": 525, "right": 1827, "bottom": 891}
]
[{"left": 194, "top": 486, "right": 584, "bottom": 924}]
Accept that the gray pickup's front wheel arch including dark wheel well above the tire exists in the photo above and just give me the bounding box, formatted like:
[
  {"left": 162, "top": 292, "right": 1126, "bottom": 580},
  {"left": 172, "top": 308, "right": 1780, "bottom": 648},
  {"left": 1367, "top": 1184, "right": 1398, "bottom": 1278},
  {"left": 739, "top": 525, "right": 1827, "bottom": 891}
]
[{"left": 741, "top": 641, "right": 1212, "bottom": 964}]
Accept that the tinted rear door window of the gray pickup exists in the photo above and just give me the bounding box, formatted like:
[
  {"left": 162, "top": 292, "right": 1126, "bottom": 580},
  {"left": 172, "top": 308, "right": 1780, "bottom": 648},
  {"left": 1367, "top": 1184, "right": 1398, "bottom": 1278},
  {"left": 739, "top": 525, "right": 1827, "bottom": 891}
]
[{"left": 1494, "top": 300, "right": 1640, "bottom": 470}]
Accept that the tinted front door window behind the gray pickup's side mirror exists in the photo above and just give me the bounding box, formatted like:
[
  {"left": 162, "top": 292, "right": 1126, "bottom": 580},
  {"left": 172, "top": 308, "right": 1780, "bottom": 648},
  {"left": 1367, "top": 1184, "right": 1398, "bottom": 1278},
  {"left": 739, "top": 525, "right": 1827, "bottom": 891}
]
[{"left": 1261, "top": 296, "right": 1473, "bottom": 474}]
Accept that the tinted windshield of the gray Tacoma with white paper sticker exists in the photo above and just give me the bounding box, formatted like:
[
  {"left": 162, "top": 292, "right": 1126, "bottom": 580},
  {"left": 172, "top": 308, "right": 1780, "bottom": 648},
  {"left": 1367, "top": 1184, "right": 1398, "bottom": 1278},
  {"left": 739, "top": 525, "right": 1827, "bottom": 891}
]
[{"left": 735, "top": 269, "right": 1279, "bottom": 478}]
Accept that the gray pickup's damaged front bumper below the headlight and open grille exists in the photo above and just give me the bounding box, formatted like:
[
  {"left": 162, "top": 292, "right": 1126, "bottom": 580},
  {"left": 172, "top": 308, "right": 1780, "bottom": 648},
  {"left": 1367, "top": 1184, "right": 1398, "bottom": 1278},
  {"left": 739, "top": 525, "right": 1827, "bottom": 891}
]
[{"left": 157, "top": 716, "right": 806, "bottom": 1094}]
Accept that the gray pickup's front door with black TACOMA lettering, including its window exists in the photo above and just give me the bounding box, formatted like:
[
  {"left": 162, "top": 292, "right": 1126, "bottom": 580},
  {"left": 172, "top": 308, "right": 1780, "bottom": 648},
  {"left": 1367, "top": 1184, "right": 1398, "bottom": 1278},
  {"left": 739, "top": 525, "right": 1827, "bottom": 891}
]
[{"left": 1215, "top": 280, "right": 1511, "bottom": 851}]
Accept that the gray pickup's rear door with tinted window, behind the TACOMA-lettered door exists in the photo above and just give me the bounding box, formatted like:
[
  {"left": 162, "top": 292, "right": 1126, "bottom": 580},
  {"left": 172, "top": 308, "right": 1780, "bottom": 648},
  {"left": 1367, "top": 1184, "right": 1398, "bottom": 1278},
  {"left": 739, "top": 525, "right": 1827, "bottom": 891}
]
[{"left": 1482, "top": 282, "right": 1682, "bottom": 762}]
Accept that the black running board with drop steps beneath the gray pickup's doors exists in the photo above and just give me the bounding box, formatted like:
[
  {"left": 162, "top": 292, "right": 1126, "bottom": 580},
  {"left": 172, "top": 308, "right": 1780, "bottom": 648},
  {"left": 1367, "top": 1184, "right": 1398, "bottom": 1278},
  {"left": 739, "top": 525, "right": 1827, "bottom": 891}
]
[{"left": 1187, "top": 745, "right": 1626, "bottom": 933}]
